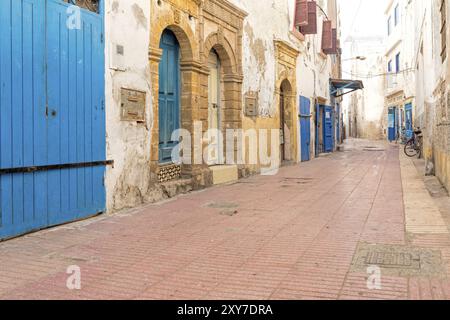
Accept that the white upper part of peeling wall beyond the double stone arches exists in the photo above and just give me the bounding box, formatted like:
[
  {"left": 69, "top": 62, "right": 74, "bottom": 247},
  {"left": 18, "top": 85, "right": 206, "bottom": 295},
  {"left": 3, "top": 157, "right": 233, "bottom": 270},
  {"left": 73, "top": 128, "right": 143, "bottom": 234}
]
[{"left": 231, "top": 0, "right": 331, "bottom": 117}]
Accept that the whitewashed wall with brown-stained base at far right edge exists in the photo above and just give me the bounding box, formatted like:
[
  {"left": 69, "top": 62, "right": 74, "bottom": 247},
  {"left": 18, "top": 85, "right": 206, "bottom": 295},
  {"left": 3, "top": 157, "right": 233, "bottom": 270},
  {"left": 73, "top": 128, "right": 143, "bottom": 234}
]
[{"left": 414, "top": 0, "right": 450, "bottom": 189}]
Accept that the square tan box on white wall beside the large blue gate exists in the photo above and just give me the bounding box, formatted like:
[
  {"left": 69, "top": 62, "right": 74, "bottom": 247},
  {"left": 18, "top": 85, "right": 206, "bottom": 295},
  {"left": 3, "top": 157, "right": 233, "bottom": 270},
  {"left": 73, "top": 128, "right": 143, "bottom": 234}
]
[{"left": 120, "top": 88, "right": 146, "bottom": 122}]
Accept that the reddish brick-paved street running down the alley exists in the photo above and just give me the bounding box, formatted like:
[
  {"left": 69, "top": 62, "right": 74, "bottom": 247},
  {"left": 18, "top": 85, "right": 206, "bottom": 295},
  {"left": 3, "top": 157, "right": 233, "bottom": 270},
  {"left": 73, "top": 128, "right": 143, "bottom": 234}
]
[{"left": 0, "top": 145, "right": 450, "bottom": 299}]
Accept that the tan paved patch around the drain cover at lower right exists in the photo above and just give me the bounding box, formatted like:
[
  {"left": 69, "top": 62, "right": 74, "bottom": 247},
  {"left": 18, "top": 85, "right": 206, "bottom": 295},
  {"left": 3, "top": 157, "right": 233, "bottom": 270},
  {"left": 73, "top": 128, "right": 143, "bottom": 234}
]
[{"left": 352, "top": 243, "right": 446, "bottom": 277}]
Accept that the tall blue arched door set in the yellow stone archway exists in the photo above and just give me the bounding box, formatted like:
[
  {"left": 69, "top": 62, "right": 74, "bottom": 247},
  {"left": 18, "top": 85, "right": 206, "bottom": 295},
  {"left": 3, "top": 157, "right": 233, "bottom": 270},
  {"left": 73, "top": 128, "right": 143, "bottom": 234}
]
[{"left": 158, "top": 30, "right": 180, "bottom": 164}]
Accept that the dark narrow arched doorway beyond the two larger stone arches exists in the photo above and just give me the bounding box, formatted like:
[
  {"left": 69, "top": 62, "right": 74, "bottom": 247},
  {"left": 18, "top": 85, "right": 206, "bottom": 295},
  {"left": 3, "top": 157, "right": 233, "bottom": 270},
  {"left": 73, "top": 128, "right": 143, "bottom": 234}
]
[{"left": 280, "top": 80, "right": 292, "bottom": 162}]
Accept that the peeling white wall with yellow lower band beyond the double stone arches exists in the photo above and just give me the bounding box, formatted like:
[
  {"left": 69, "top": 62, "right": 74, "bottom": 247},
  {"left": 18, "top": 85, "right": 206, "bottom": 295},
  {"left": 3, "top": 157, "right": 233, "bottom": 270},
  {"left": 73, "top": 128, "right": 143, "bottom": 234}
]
[{"left": 231, "top": 0, "right": 339, "bottom": 161}]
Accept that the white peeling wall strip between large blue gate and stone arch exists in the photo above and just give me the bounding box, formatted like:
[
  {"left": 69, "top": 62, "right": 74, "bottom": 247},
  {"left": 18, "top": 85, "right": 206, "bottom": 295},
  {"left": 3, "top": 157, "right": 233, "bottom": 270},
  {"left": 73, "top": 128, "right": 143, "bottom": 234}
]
[{"left": 105, "top": 0, "right": 153, "bottom": 211}]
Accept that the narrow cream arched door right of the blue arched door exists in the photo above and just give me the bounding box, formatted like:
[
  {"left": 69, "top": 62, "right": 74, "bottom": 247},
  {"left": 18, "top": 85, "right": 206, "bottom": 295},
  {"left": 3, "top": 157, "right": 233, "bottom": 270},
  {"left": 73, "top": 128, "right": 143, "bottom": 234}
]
[{"left": 208, "top": 49, "right": 223, "bottom": 165}]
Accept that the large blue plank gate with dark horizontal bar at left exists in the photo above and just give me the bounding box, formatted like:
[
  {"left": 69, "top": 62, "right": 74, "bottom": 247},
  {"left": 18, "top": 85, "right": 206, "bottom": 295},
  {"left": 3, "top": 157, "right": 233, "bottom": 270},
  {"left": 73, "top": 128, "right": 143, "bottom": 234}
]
[{"left": 0, "top": 0, "right": 106, "bottom": 239}]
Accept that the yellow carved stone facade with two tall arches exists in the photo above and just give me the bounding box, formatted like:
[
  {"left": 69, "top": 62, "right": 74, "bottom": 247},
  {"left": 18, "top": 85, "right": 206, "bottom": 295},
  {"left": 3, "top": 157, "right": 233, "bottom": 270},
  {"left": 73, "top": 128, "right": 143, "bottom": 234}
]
[{"left": 149, "top": 0, "right": 246, "bottom": 186}]
